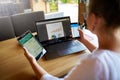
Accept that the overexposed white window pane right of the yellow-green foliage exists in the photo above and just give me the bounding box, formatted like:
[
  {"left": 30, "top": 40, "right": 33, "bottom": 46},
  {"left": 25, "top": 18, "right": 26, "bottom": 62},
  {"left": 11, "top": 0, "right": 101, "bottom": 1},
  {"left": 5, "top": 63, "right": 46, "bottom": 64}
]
[{"left": 58, "top": 0, "right": 78, "bottom": 22}]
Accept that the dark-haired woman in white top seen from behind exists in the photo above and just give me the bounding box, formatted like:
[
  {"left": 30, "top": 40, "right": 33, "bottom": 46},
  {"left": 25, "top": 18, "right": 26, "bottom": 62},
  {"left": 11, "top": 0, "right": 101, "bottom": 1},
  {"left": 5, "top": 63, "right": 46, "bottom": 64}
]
[{"left": 25, "top": 0, "right": 120, "bottom": 80}]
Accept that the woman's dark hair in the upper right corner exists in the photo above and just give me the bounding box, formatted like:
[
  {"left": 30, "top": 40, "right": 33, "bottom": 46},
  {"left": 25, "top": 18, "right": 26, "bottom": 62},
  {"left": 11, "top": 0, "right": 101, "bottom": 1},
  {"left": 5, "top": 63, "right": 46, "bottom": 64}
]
[{"left": 89, "top": 0, "right": 120, "bottom": 28}]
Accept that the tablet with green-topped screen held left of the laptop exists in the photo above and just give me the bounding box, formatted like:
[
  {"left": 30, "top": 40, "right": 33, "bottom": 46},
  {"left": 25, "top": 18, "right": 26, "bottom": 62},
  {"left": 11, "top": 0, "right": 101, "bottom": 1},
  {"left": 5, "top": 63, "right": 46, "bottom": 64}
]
[{"left": 17, "top": 30, "right": 46, "bottom": 60}]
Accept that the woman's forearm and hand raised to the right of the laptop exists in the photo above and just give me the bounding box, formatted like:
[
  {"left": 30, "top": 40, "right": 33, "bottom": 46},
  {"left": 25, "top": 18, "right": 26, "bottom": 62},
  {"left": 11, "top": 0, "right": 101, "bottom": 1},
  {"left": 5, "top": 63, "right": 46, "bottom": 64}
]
[{"left": 79, "top": 30, "right": 97, "bottom": 52}]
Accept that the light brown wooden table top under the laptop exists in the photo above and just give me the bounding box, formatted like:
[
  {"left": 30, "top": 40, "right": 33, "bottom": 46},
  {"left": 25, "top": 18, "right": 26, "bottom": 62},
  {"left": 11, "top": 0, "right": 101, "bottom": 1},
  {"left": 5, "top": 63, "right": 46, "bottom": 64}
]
[{"left": 0, "top": 38, "right": 89, "bottom": 80}]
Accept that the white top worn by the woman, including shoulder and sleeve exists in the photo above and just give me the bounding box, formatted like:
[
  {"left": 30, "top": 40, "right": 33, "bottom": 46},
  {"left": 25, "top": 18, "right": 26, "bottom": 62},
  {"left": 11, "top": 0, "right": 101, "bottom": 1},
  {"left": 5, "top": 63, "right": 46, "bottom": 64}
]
[{"left": 41, "top": 50, "right": 120, "bottom": 80}]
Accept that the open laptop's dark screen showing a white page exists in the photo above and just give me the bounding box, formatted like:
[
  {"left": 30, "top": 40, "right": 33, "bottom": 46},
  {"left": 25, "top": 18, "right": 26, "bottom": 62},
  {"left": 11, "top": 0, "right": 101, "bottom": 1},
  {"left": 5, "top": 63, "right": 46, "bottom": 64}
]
[{"left": 36, "top": 17, "right": 72, "bottom": 42}]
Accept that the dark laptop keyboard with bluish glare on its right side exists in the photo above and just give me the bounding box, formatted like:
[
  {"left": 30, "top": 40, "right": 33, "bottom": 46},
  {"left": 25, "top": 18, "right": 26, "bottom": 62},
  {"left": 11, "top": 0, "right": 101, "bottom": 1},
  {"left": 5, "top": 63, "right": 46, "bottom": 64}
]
[{"left": 46, "top": 40, "right": 85, "bottom": 56}]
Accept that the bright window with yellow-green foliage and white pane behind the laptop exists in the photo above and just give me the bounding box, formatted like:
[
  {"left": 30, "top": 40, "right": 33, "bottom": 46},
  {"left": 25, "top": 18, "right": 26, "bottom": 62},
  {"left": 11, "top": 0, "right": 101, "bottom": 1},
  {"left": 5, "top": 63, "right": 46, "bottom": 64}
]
[{"left": 46, "top": 0, "right": 78, "bottom": 22}]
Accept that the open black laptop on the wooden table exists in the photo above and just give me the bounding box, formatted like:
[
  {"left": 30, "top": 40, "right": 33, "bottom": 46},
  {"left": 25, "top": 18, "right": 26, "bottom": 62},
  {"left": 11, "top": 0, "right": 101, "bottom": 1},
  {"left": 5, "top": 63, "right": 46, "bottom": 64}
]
[{"left": 35, "top": 16, "right": 85, "bottom": 60}]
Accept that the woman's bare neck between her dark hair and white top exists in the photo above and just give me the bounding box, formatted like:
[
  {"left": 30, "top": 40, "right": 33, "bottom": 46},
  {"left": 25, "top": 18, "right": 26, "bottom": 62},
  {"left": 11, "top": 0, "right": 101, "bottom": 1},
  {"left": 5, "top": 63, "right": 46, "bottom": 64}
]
[{"left": 98, "top": 29, "right": 120, "bottom": 53}]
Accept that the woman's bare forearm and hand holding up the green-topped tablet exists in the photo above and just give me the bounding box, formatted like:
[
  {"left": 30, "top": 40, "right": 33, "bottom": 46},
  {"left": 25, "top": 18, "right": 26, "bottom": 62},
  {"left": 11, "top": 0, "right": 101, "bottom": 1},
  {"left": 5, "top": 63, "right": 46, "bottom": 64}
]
[{"left": 24, "top": 48, "right": 47, "bottom": 79}]
